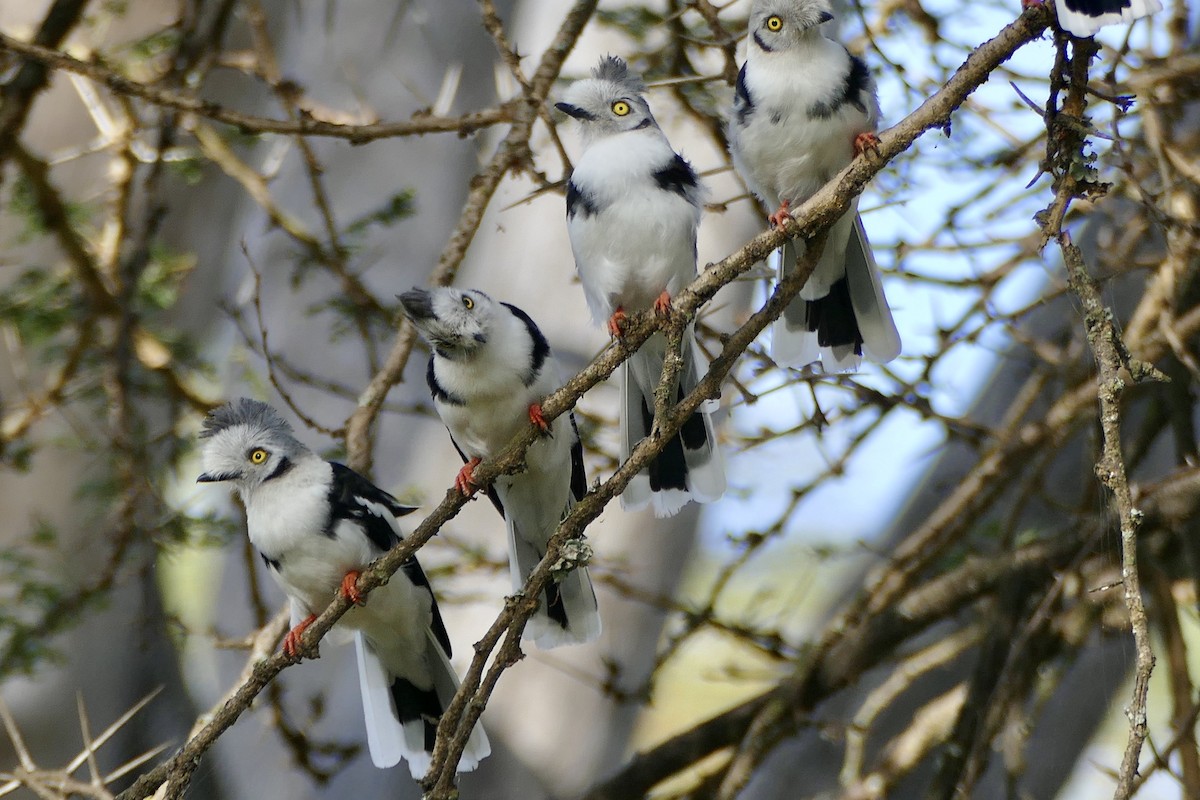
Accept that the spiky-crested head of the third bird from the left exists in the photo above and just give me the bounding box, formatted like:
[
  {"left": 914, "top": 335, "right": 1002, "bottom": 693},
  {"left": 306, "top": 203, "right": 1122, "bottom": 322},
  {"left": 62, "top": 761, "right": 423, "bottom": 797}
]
[{"left": 554, "top": 55, "right": 658, "bottom": 142}]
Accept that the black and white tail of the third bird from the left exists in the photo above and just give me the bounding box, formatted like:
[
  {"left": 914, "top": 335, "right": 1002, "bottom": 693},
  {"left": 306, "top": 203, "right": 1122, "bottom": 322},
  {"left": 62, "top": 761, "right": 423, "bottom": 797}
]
[{"left": 620, "top": 327, "right": 725, "bottom": 517}]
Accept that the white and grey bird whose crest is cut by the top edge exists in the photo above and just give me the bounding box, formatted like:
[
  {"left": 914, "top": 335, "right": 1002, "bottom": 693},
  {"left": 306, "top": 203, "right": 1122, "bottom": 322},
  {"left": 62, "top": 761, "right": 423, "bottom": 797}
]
[{"left": 726, "top": 0, "right": 900, "bottom": 371}]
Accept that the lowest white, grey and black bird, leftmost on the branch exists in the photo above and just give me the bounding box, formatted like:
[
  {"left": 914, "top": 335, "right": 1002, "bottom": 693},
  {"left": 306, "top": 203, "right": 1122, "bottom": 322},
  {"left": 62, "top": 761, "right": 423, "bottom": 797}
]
[{"left": 197, "top": 397, "right": 491, "bottom": 777}]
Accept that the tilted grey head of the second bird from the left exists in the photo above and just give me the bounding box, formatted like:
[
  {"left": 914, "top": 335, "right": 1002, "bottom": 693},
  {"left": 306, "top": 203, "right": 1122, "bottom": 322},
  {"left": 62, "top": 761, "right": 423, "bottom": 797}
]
[{"left": 400, "top": 287, "right": 498, "bottom": 361}]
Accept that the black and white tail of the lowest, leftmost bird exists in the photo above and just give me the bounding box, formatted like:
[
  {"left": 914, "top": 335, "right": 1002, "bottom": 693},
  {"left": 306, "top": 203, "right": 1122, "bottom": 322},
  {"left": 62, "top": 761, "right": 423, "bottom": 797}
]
[{"left": 354, "top": 631, "right": 492, "bottom": 778}]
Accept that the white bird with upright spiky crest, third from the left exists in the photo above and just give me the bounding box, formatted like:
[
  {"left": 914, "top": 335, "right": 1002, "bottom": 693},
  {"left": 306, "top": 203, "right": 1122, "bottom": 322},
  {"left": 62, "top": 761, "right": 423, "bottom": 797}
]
[{"left": 557, "top": 56, "right": 725, "bottom": 517}]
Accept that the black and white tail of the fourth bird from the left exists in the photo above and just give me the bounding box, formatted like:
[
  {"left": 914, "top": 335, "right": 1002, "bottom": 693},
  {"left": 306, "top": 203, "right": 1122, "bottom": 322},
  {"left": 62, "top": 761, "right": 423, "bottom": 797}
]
[{"left": 770, "top": 212, "right": 900, "bottom": 372}]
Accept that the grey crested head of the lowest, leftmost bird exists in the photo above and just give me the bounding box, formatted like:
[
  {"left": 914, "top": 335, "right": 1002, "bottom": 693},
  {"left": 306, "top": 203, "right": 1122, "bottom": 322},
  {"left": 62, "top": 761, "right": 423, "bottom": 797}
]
[{"left": 196, "top": 397, "right": 308, "bottom": 498}]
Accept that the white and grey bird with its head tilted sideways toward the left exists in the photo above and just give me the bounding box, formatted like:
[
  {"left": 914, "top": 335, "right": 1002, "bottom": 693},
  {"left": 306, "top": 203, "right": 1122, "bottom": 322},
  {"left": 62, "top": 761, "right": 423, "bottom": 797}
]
[{"left": 400, "top": 288, "right": 600, "bottom": 649}]
